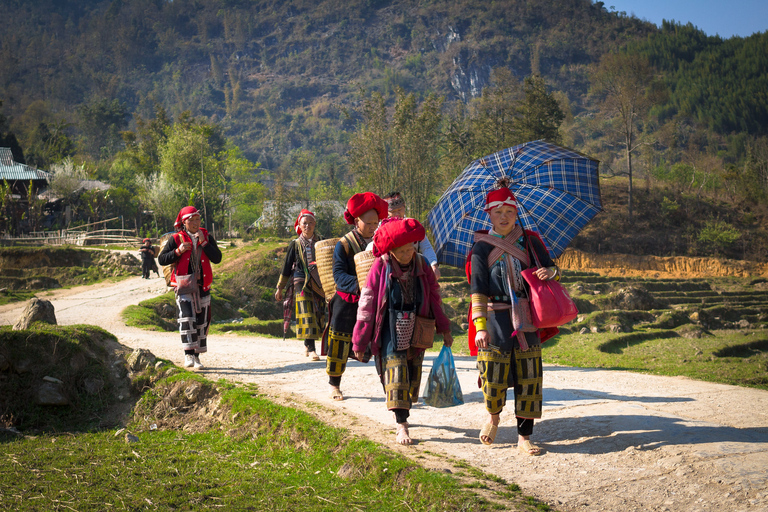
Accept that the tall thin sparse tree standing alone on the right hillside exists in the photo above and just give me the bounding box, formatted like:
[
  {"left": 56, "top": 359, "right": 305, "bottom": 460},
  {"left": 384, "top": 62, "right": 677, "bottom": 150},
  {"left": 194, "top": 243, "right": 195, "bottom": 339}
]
[{"left": 591, "top": 53, "right": 664, "bottom": 223}]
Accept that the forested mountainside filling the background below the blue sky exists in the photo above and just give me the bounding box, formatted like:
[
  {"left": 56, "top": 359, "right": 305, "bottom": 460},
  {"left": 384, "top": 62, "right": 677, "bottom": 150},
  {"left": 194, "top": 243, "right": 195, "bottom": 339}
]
[{"left": 0, "top": 0, "right": 768, "bottom": 262}]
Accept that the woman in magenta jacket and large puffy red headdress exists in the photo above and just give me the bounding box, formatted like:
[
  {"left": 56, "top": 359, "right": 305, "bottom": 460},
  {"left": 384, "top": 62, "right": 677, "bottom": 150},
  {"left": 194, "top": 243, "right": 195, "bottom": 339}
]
[{"left": 352, "top": 218, "right": 453, "bottom": 445}]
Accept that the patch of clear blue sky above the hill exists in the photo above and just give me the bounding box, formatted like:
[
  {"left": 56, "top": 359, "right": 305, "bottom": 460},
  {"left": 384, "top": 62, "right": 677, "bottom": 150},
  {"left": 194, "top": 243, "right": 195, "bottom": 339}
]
[{"left": 603, "top": 0, "right": 768, "bottom": 39}]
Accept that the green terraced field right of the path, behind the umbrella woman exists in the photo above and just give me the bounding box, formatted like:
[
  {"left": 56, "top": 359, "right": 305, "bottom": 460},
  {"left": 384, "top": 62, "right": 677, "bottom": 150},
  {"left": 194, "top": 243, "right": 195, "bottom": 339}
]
[{"left": 440, "top": 268, "right": 768, "bottom": 389}]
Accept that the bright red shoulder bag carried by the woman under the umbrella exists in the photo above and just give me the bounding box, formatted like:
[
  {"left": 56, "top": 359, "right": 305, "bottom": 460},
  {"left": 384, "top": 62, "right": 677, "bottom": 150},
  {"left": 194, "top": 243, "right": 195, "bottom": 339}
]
[{"left": 521, "top": 237, "right": 579, "bottom": 329}]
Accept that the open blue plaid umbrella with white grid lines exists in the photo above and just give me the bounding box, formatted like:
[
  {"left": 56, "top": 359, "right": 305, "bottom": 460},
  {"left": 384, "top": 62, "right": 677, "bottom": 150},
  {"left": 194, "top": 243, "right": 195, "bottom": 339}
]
[{"left": 427, "top": 140, "right": 602, "bottom": 267}]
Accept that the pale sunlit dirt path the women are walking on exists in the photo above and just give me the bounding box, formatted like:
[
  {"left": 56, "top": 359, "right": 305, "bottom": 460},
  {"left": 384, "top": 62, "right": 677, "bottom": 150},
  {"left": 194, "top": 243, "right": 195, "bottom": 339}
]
[{"left": 0, "top": 277, "right": 768, "bottom": 512}]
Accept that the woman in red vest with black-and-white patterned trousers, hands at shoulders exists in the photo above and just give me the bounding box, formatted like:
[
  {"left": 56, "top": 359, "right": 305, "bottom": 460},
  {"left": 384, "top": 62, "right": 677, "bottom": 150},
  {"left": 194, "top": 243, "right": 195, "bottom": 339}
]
[{"left": 158, "top": 206, "right": 221, "bottom": 370}]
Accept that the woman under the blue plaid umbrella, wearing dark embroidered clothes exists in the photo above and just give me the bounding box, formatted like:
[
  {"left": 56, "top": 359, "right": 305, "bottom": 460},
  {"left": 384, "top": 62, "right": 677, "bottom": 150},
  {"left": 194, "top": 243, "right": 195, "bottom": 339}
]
[{"left": 468, "top": 187, "right": 559, "bottom": 455}]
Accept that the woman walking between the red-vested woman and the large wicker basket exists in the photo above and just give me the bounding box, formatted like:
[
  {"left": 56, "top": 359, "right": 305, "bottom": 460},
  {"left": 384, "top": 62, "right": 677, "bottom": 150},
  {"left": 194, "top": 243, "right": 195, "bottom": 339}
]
[{"left": 275, "top": 210, "right": 326, "bottom": 361}]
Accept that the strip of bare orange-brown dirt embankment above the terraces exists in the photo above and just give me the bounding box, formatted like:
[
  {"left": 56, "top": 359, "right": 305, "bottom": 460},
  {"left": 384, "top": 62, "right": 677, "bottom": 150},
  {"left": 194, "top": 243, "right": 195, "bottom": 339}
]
[{"left": 558, "top": 249, "right": 768, "bottom": 278}]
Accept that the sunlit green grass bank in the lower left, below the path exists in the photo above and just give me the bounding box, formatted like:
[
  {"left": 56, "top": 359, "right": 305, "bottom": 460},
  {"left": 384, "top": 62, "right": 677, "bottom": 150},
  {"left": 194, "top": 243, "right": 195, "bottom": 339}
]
[{"left": 0, "top": 371, "right": 516, "bottom": 511}]
